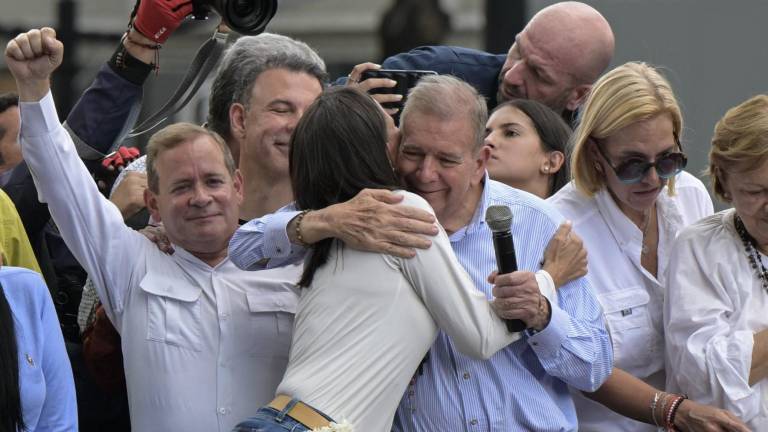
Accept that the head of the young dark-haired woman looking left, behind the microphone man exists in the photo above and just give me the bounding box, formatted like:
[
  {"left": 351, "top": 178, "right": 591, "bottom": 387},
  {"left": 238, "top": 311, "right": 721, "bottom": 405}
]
[{"left": 485, "top": 99, "right": 572, "bottom": 198}]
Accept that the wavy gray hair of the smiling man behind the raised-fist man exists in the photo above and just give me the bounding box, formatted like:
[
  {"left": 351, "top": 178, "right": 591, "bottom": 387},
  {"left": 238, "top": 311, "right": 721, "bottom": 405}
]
[{"left": 207, "top": 33, "right": 328, "bottom": 141}]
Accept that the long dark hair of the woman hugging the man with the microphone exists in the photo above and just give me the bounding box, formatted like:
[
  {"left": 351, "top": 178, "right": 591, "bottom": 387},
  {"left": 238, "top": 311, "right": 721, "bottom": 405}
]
[{"left": 289, "top": 87, "right": 400, "bottom": 287}]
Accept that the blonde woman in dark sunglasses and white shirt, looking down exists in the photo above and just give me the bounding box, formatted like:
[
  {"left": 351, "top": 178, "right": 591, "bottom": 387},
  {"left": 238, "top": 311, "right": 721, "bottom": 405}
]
[{"left": 551, "top": 63, "right": 744, "bottom": 431}]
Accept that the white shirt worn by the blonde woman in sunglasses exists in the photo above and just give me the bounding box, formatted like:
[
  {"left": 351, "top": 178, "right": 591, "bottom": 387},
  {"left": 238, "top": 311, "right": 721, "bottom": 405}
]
[{"left": 549, "top": 172, "right": 713, "bottom": 431}]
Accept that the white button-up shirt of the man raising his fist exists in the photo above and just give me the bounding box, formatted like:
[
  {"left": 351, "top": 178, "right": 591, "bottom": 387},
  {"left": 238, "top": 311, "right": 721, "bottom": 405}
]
[{"left": 21, "top": 93, "right": 299, "bottom": 432}]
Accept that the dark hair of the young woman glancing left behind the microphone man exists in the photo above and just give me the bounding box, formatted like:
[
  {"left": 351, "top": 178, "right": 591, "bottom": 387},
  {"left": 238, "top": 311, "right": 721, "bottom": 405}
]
[{"left": 494, "top": 99, "right": 573, "bottom": 196}]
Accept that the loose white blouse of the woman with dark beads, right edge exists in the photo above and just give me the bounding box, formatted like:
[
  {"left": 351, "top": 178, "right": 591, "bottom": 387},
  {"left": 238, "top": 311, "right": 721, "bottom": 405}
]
[{"left": 664, "top": 209, "right": 768, "bottom": 431}]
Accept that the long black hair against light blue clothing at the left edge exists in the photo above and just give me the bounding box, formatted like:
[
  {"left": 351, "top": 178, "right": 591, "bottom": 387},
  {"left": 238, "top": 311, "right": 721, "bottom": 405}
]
[{"left": 0, "top": 285, "right": 26, "bottom": 432}]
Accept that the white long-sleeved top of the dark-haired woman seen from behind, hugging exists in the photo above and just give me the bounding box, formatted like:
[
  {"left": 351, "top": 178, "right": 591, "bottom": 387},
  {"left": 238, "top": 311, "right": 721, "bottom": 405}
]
[{"left": 277, "top": 192, "right": 519, "bottom": 432}]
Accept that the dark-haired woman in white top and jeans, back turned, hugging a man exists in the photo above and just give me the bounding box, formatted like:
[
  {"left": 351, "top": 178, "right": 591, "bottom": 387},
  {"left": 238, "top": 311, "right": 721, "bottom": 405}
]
[{"left": 231, "top": 88, "right": 519, "bottom": 432}]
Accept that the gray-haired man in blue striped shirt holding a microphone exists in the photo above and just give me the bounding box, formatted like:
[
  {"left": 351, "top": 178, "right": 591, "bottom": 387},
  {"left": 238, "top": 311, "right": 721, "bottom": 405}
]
[{"left": 230, "top": 76, "right": 612, "bottom": 432}]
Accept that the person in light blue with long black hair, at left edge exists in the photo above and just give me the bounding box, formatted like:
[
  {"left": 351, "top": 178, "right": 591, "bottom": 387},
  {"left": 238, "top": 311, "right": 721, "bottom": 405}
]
[{"left": 0, "top": 267, "right": 77, "bottom": 432}]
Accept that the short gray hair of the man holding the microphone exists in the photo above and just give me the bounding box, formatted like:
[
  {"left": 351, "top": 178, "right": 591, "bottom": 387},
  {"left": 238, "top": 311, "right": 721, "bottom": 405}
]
[{"left": 400, "top": 75, "right": 488, "bottom": 153}]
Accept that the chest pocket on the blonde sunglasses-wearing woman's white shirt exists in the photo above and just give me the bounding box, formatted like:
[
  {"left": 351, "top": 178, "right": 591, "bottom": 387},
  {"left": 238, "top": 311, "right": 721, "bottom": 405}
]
[{"left": 598, "top": 286, "right": 664, "bottom": 377}]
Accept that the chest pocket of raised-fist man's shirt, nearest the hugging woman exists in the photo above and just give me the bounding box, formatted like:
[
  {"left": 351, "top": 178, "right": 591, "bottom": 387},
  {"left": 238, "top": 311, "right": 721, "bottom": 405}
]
[{"left": 246, "top": 292, "right": 297, "bottom": 359}]
